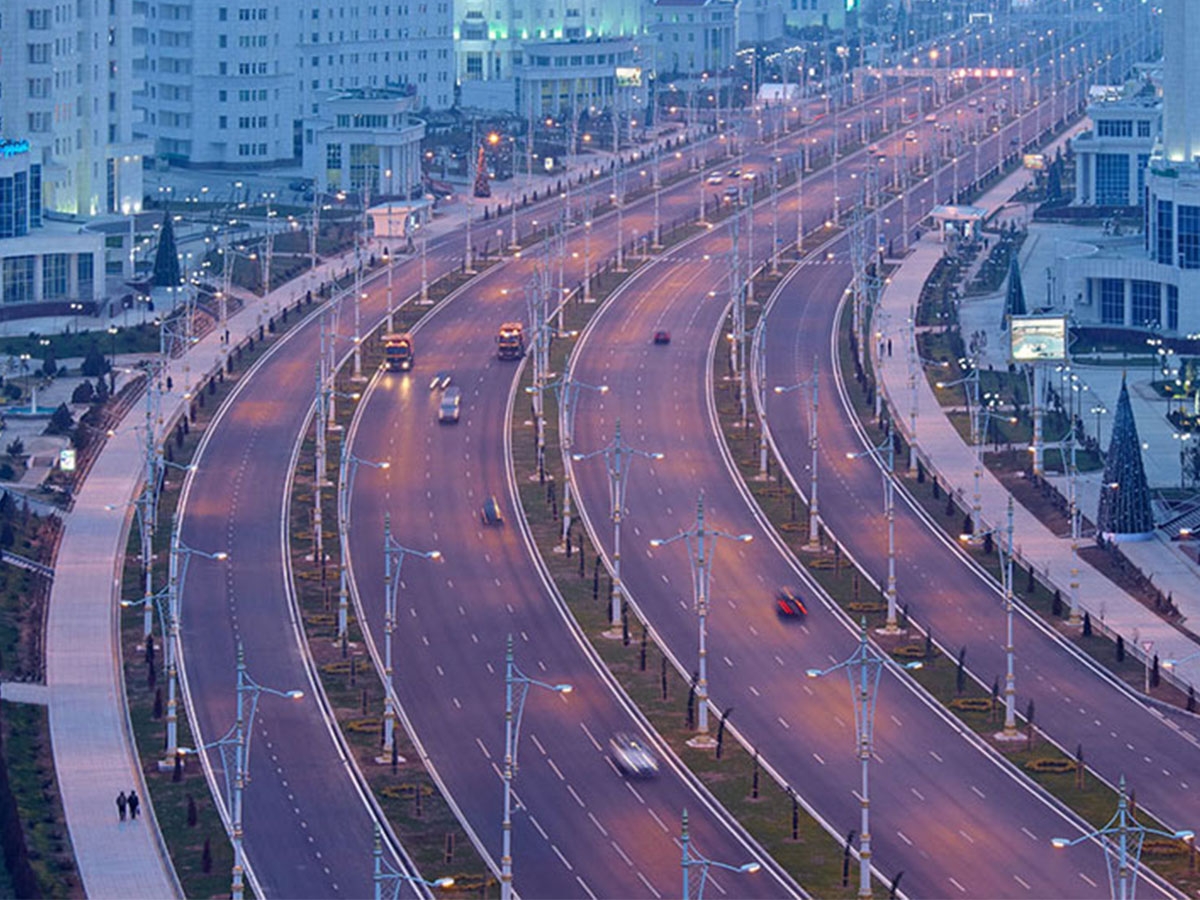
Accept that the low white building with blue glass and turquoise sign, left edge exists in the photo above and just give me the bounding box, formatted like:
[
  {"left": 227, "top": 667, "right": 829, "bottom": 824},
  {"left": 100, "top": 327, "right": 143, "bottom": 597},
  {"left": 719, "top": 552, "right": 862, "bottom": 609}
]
[{"left": 0, "top": 140, "right": 104, "bottom": 318}]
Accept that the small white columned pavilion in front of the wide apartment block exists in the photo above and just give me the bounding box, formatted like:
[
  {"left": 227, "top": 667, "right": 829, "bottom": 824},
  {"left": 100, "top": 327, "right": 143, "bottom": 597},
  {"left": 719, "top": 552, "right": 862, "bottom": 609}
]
[{"left": 304, "top": 86, "right": 425, "bottom": 199}]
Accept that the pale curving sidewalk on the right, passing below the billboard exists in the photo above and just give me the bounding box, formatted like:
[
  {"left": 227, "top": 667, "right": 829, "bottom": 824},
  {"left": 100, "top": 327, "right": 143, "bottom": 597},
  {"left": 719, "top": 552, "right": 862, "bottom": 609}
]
[{"left": 871, "top": 160, "right": 1200, "bottom": 684}]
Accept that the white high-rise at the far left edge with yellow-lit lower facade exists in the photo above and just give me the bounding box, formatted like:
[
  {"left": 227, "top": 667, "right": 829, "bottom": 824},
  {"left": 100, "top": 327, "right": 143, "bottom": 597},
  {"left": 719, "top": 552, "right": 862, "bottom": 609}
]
[{"left": 0, "top": 0, "right": 146, "bottom": 216}]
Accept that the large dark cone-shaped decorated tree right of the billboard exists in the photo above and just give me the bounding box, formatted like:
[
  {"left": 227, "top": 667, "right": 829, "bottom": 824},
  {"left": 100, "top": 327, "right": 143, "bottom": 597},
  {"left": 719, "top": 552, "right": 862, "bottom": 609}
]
[{"left": 1096, "top": 380, "right": 1154, "bottom": 540}]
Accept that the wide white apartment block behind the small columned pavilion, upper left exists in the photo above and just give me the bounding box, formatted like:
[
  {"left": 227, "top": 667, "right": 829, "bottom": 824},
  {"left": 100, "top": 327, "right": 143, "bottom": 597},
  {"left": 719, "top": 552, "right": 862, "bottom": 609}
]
[{"left": 139, "top": 0, "right": 454, "bottom": 167}]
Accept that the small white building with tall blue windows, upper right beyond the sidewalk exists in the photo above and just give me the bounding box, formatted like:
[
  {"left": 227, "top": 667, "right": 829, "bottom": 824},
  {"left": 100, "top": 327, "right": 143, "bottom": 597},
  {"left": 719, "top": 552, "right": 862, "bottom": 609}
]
[{"left": 1070, "top": 85, "right": 1162, "bottom": 206}]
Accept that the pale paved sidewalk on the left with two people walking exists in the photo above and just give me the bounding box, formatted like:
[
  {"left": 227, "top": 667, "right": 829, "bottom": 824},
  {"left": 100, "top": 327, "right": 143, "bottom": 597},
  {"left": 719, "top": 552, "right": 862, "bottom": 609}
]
[{"left": 44, "top": 243, "right": 360, "bottom": 899}]
